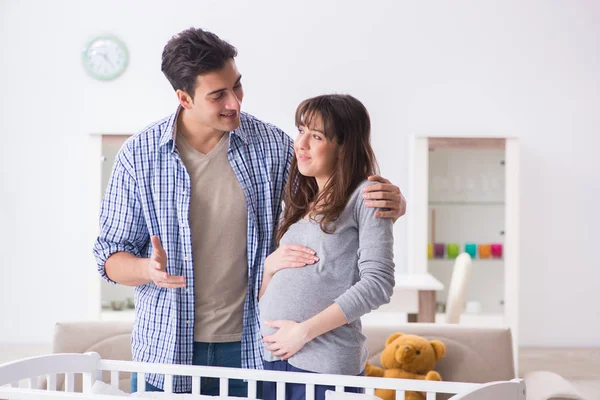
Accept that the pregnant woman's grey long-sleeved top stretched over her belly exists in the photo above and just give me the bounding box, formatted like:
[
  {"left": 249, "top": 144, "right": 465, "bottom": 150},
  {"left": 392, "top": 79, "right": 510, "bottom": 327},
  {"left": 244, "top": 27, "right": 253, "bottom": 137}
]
[{"left": 259, "top": 181, "right": 395, "bottom": 375}]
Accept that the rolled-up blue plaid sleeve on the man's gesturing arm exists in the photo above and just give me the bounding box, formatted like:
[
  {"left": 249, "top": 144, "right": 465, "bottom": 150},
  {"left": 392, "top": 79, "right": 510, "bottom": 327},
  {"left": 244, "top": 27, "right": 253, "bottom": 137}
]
[{"left": 94, "top": 151, "right": 150, "bottom": 283}]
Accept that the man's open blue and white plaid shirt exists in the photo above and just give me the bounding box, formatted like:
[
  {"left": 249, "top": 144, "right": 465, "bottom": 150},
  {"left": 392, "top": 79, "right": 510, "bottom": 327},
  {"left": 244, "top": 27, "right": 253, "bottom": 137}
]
[{"left": 94, "top": 108, "right": 293, "bottom": 392}]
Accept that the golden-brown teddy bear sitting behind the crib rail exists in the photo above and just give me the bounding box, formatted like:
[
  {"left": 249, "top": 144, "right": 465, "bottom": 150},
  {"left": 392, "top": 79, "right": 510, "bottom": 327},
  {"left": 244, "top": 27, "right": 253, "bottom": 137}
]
[{"left": 365, "top": 333, "right": 446, "bottom": 400}]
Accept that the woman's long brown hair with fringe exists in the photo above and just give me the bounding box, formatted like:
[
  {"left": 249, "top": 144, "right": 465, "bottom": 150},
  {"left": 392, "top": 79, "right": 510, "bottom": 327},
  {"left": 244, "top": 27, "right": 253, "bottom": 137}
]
[{"left": 276, "top": 94, "right": 377, "bottom": 244}]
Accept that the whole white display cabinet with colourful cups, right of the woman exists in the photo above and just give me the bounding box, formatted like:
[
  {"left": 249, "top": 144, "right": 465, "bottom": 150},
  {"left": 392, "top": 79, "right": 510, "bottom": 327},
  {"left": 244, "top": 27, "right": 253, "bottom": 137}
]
[{"left": 407, "top": 135, "right": 519, "bottom": 340}]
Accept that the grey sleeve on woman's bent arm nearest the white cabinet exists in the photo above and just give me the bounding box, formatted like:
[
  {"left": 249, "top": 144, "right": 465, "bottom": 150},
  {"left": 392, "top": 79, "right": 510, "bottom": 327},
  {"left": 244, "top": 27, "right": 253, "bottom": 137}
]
[{"left": 335, "top": 191, "right": 395, "bottom": 322}]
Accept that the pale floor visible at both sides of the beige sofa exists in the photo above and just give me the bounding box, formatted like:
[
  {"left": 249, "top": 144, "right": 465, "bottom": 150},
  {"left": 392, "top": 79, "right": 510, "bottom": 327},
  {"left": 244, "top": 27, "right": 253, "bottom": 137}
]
[{"left": 0, "top": 344, "right": 600, "bottom": 400}]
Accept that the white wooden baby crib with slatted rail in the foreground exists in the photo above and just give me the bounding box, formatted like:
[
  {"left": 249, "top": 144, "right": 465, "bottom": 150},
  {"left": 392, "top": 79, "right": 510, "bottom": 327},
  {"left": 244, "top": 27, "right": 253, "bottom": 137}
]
[{"left": 0, "top": 353, "right": 525, "bottom": 400}]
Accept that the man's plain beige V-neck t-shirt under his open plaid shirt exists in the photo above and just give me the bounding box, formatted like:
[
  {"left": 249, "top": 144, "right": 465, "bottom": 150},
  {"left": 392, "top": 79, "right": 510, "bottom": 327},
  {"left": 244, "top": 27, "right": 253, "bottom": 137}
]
[{"left": 176, "top": 133, "right": 248, "bottom": 343}]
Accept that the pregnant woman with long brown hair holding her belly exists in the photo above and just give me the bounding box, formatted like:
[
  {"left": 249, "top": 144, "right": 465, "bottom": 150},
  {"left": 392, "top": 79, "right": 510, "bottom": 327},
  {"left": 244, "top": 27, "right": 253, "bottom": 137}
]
[{"left": 259, "top": 95, "right": 394, "bottom": 400}]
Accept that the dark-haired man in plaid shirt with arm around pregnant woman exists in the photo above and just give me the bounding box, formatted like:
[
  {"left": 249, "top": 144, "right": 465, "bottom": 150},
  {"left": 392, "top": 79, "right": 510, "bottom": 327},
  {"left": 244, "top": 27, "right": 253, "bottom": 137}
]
[{"left": 94, "top": 29, "right": 405, "bottom": 397}]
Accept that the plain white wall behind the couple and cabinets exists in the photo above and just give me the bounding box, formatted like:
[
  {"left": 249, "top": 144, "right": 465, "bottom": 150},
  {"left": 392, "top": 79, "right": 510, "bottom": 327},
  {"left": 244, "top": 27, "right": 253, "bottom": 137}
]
[{"left": 0, "top": 0, "right": 600, "bottom": 346}]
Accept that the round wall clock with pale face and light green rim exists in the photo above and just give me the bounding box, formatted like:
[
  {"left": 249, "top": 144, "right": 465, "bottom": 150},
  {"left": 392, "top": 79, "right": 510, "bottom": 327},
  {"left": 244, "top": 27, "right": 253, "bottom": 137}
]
[{"left": 82, "top": 36, "right": 129, "bottom": 81}]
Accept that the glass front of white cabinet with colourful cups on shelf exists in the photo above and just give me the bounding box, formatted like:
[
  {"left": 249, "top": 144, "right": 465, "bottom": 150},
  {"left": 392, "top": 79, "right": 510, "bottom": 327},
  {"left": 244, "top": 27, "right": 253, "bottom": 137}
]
[{"left": 427, "top": 143, "right": 505, "bottom": 320}]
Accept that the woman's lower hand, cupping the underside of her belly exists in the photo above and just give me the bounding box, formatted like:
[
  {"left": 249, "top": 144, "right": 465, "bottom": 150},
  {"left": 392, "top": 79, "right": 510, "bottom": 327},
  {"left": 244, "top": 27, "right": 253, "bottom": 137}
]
[{"left": 263, "top": 320, "right": 311, "bottom": 360}]
